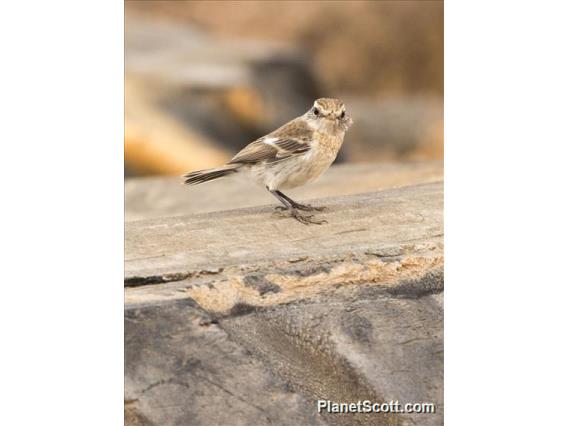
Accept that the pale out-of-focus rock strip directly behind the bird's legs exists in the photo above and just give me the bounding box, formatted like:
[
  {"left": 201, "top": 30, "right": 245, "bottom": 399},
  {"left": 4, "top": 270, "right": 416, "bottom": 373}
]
[{"left": 124, "top": 161, "right": 444, "bottom": 222}]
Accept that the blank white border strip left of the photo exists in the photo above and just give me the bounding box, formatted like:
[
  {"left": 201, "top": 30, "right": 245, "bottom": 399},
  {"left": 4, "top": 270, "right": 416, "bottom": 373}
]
[{"left": 0, "top": 1, "right": 124, "bottom": 426}]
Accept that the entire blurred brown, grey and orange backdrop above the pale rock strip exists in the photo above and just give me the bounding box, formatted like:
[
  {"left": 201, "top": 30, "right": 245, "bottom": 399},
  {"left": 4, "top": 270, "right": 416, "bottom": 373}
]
[{"left": 125, "top": 1, "right": 444, "bottom": 178}]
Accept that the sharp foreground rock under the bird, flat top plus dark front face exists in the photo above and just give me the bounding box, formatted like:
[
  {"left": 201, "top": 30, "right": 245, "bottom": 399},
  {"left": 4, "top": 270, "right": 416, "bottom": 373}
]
[{"left": 125, "top": 174, "right": 444, "bottom": 425}]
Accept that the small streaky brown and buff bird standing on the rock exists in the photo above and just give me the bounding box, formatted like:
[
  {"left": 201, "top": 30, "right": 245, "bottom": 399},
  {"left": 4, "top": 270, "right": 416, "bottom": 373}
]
[{"left": 183, "top": 98, "right": 353, "bottom": 225}]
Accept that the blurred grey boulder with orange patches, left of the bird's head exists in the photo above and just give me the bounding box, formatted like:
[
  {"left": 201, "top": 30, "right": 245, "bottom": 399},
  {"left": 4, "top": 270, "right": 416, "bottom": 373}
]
[{"left": 125, "top": 14, "right": 318, "bottom": 174}]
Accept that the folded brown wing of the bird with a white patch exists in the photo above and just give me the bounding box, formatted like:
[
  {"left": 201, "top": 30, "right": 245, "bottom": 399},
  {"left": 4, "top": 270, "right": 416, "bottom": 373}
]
[{"left": 229, "top": 121, "right": 313, "bottom": 164}]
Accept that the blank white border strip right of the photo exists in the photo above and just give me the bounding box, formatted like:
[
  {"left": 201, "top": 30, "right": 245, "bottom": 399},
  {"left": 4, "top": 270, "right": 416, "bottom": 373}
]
[{"left": 445, "top": 1, "right": 568, "bottom": 425}]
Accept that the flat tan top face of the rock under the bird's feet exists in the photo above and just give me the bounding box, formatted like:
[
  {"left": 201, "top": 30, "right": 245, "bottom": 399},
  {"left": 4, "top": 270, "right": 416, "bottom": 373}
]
[{"left": 125, "top": 182, "right": 443, "bottom": 284}]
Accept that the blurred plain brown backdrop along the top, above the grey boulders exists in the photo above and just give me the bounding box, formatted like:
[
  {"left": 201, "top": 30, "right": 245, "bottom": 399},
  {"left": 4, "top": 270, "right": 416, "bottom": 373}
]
[{"left": 126, "top": 0, "right": 444, "bottom": 96}]
